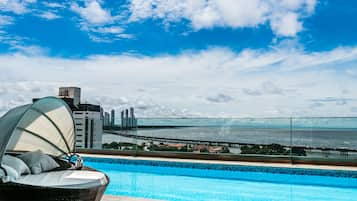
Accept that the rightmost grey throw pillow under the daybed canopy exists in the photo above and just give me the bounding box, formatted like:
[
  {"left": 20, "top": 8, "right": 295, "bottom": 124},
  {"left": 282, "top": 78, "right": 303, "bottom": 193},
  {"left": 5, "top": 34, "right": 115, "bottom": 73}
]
[{"left": 18, "top": 150, "right": 59, "bottom": 174}]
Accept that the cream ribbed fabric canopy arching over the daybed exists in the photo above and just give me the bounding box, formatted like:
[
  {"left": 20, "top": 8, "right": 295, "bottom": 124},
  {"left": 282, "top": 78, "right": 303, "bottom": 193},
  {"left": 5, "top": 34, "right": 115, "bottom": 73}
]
[{"left": 0, "top": 97, "right": 75, "bottom": 161}]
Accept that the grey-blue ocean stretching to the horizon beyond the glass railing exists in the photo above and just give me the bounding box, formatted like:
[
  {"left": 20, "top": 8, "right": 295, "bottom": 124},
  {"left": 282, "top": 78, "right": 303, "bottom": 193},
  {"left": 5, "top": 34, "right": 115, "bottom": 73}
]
[{"left": 104, "top": 117, "right": 357, "bottom": 150}]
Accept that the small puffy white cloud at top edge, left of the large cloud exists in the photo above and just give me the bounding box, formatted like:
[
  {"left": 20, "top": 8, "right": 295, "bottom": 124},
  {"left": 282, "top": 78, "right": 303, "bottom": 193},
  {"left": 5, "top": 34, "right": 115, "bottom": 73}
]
[{"left": 71, "top": 0, "right": 113, "bottom": 25}]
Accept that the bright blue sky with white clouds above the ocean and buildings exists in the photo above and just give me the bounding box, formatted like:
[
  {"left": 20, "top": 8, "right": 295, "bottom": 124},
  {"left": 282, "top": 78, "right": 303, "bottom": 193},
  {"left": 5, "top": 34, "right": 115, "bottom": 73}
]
[{"left": 0, "top": 0, "right": 357, "bottom": 117}]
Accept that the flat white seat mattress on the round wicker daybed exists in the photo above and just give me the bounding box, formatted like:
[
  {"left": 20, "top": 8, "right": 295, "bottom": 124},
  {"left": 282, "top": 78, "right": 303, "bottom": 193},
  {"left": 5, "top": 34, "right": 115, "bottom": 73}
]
[{"left": 16, "top": 170, "right": 108, "bottom": 189}]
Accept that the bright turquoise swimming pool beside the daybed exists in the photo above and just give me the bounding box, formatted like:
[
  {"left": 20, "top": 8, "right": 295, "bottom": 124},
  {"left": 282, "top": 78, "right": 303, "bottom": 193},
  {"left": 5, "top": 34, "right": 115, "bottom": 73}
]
[{"left": 85, "top": 158, "right": 357, "bottom": 201}]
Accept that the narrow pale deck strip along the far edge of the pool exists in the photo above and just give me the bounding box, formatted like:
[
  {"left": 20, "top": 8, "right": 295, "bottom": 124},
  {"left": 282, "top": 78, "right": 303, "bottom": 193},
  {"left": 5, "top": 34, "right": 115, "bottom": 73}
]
[{"left": 81, "top": 154, "right": 357, "bottom": 171}]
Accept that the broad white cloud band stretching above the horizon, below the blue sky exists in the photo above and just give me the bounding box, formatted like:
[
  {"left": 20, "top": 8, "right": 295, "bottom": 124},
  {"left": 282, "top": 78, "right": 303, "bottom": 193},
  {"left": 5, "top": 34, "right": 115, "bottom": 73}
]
[{"left": 0, "top": 45, "right": 357, "bottom": 117}]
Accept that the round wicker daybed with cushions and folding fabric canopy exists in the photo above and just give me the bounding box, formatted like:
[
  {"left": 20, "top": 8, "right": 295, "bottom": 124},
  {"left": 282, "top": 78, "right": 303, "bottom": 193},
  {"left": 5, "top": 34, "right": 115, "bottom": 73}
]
[{"left": 0, "top": 97, "right": 109, "bottom": 201}]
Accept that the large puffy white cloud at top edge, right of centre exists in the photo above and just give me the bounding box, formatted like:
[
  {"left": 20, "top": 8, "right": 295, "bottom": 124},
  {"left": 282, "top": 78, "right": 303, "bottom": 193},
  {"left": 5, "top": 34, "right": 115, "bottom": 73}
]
[{"left": 130, "top": 0, "right": 316, "bottom": 36}]
